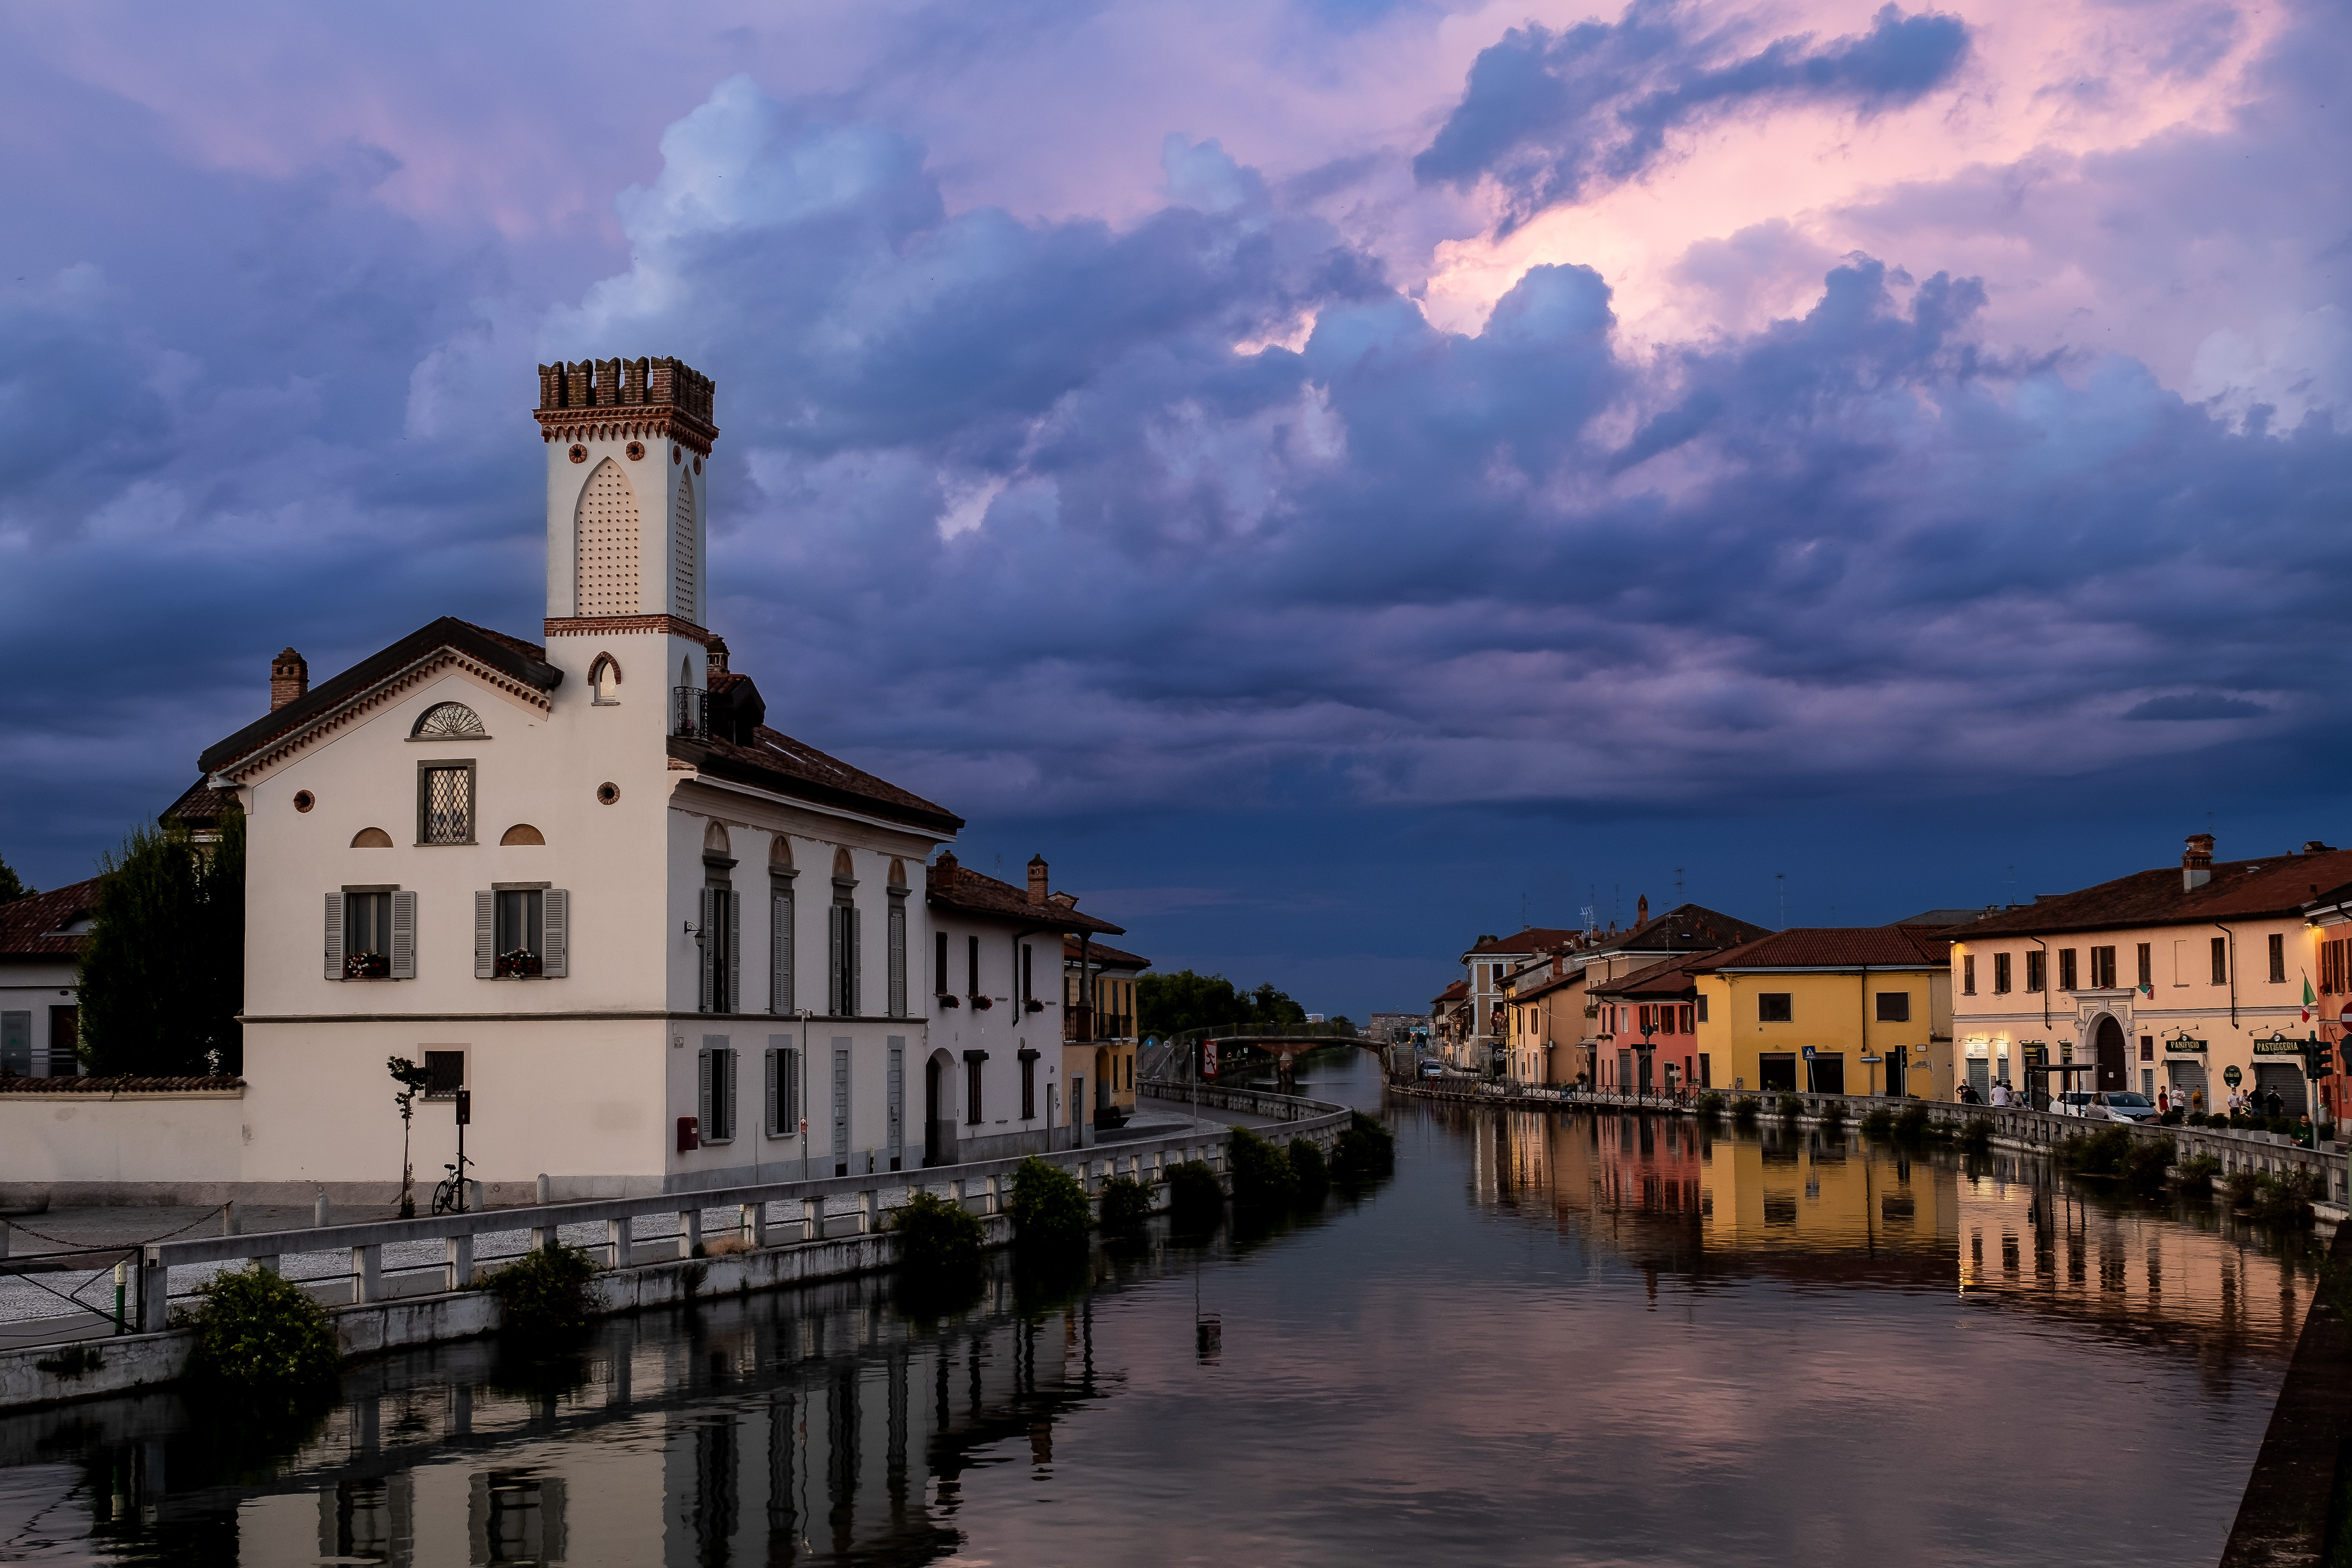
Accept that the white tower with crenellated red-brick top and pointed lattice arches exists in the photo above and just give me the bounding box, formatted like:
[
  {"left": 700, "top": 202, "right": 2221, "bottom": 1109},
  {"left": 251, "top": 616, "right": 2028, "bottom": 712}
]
[{"left": 531, "top": 360, "right": 718, "bottom": 703}]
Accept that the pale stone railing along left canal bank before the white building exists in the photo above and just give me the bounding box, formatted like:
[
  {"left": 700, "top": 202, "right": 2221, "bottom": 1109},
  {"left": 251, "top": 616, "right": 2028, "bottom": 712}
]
[{"left": 103, "top": 1112, "right": 1251, "bottom": 1333}]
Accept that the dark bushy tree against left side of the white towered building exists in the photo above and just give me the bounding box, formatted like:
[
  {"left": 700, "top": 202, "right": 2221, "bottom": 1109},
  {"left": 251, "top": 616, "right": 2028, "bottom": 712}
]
[{"left": 80, "top": 811, "right": 245, "bottom": 1077}]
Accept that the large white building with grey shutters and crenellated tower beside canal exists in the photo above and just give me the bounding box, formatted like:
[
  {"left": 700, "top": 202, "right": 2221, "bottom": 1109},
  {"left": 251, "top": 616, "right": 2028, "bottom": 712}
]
[{"left": 179, "top": 360, "right": 1117, "bottom": 1201}]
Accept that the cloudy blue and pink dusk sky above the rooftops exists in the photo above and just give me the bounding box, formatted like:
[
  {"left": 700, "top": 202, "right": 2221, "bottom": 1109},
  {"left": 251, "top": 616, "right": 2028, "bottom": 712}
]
[{"left": 0, "top": 0, "right": 2352, "bottom": 1013}]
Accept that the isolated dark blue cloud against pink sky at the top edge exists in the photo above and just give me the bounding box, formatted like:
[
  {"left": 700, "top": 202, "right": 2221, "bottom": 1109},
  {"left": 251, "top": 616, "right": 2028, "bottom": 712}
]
[{"left": 1414, "top": 0, "right": 1969, "bottom": 233}]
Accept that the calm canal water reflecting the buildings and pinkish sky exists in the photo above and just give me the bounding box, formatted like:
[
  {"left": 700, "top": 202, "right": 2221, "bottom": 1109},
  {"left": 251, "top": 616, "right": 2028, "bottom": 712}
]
[{"left": 0, "top": 1053, "right": 2312, "bottom": 1568}]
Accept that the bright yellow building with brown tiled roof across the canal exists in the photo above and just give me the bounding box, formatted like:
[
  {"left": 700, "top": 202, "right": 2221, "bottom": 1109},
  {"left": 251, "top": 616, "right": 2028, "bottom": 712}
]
[{"left": 1689, "top": 926, "right": 1952, "bottom": 1100}]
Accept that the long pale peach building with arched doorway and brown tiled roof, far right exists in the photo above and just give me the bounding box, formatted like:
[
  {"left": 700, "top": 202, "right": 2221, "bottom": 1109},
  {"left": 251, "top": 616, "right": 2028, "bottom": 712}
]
[{"left": 1952, "top": 832, "right": 2352, "bottom": 1117}]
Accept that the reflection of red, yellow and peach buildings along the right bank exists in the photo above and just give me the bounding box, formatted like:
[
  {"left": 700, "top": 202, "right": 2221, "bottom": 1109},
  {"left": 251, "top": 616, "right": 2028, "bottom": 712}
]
[{"left": 1486, "top": 1112, "right": 2314, "bottom": 1359}]
